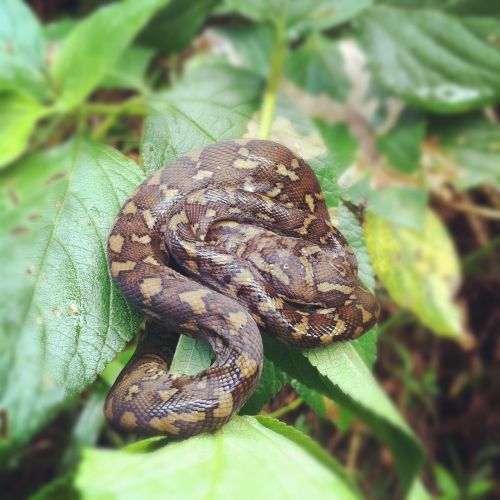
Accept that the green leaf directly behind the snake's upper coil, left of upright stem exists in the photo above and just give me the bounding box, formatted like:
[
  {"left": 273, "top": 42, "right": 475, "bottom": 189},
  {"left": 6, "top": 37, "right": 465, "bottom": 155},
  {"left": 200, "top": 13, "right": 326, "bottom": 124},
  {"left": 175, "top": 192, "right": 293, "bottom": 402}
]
[{"left": 141, "top": 59, "right": 262, "bottom": 173}]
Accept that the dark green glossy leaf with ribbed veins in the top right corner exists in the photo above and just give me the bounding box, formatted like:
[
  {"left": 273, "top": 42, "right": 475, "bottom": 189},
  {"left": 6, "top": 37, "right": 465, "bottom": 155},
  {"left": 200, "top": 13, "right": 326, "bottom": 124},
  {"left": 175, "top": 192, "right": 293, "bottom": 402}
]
[{"left": 359, "top": 5, "right": 500, "bottom": 112}]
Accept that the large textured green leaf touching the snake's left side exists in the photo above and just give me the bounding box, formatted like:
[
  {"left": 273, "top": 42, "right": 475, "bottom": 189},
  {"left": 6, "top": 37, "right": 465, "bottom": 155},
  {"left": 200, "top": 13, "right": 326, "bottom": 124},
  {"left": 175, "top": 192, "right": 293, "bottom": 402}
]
[{"left": 0, "top": 139, "right": 142, "bottom": 462}]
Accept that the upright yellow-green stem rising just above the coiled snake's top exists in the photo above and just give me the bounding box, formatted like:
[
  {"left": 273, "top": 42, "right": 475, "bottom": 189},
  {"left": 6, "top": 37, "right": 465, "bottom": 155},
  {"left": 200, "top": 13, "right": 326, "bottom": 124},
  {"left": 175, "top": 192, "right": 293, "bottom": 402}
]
[{"left": 259, "top": 17, "right": 287, "bottom": 139}]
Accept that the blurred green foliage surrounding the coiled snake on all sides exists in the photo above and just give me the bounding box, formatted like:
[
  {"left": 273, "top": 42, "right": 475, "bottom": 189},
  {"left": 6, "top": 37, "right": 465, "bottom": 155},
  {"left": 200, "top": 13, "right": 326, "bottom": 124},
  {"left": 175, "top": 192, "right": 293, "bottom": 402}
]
[{"left": 0, "top": 0, "right": 500, "bottom": 499}]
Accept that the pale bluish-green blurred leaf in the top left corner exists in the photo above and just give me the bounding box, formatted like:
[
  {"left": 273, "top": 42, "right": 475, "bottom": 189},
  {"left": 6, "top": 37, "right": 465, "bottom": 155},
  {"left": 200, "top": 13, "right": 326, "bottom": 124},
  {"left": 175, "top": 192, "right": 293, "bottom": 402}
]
[{"left": 0, "top": 0, "right": 48, "bottom": 99}]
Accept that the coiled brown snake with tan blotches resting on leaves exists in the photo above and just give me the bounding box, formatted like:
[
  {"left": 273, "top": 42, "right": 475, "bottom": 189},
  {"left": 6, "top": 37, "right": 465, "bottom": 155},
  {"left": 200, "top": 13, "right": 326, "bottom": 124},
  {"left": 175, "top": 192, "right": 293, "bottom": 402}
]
[{"left": 104, "top": 139, "right": 380, "bottom": 438}]
